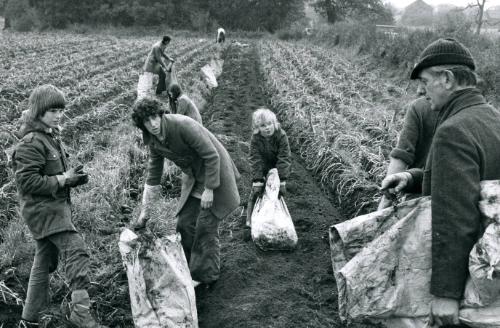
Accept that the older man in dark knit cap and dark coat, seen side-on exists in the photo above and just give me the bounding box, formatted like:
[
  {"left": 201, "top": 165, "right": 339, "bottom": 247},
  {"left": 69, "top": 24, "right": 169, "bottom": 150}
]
[{"left": 382, "top": 39, "right": 500, "bottom": 327}]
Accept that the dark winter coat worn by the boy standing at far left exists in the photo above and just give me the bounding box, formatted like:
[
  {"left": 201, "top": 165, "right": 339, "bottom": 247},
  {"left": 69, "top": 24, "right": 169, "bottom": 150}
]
[{"left": 13, "top": 120, "right": 76, "bottom": 239}]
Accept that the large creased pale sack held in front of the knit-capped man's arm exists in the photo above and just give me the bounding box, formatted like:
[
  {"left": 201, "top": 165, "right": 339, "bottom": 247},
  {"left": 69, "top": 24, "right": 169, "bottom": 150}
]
[{"left": 330, "top": 197, "right": 432, "bottom": 319}]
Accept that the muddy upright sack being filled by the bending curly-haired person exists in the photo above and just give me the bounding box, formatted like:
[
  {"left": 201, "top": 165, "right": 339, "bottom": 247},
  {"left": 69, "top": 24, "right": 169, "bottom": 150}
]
[{"left": 119, "top": 229, "right": 198, "bottom": 328}]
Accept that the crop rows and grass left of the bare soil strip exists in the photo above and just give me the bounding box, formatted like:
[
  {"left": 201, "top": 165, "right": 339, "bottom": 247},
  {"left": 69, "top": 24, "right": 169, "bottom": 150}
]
[{"left": 0, "top": 33, "right": 221, "bottom": 327}]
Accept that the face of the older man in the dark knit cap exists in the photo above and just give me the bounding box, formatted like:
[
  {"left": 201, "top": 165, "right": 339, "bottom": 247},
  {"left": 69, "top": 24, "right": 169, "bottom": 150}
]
[{"left": 417, "top": 68, "right": 451, "bottom": 110}]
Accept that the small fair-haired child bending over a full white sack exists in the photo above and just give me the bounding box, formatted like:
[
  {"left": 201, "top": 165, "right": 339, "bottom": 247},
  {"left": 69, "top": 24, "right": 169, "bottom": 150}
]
[{"left": 246, "top": 108, "right": 291, "bottom": 227}]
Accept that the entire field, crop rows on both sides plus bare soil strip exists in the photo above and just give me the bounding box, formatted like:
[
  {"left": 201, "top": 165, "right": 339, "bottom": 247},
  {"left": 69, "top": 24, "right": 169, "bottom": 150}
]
[{"left": 0, "top": 33, "right": 422, "bottom": 328}]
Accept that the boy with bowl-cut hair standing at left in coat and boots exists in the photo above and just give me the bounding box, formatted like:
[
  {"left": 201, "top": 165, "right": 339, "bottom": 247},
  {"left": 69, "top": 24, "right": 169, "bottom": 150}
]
[{"left": 13, "top": 85, "right": 108, "bottom": 328}]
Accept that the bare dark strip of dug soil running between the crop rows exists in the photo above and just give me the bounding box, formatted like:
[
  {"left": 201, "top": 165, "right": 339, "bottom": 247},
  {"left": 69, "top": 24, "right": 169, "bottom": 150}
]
[{"left": 197, "top": 44, "right": 376, "bottom": 328}]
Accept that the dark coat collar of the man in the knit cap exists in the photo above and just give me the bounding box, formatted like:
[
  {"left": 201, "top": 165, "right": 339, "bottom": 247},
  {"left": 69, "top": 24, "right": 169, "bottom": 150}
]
[{"left": 436, "top": 88, "right": 487, "bottom": 129}]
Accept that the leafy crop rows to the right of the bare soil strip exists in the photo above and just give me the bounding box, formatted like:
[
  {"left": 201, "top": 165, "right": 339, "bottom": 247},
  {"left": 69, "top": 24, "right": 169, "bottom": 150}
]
[{"left": 259, "top": 40, "right": 413, "bottom": 214}]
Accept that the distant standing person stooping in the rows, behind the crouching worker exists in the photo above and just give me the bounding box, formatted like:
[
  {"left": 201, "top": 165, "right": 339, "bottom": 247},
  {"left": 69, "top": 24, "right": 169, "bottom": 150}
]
[{"left": 143, "top": 35, "right": 175, "bottom": 95}]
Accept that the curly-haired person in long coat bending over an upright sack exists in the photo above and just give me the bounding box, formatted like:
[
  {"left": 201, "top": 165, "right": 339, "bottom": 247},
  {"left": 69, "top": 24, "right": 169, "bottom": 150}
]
[{"left": 132, "top": 97, "right": 240, "bottom": 284}]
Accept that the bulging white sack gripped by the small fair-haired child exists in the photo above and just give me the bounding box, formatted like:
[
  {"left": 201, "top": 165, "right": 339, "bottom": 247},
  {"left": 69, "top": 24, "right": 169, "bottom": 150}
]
[{"left": 251, "top": 169, "right": 297, "bottom": 250}]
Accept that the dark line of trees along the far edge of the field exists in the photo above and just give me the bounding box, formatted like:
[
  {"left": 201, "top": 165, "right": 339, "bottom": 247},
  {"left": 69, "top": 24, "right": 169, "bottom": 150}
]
[{"left": 0, "top": 0, "right": 392, "bottom": 33}]
